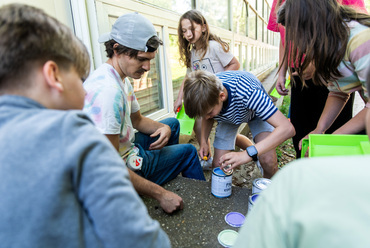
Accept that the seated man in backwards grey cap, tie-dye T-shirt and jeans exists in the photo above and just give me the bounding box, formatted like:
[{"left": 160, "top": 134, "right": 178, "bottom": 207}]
[{"left": 84, "top": 13, "right": 205, "bottom": 213}]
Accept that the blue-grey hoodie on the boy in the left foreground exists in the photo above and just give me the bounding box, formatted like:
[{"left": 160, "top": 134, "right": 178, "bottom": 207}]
[{"left": 0, "top": 95, "right": 170, "bottom": 248}]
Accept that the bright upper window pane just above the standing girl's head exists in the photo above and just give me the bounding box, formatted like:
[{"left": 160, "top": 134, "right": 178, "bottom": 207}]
[{"left": 197, "top": 0, "right": 229, "bottom": 29}]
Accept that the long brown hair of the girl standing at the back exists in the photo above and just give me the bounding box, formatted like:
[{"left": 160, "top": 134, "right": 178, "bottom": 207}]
[{"left": 177, "top": 9, "right": 229, "bottom": 68}]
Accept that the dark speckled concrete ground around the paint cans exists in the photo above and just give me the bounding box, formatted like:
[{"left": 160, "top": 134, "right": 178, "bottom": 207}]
[{"left": 142, "top": 69, "right": 282, "bottom": 248}]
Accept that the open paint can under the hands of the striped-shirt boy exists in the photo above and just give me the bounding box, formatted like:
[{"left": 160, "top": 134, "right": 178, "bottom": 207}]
[{"left": 211, "top": 167, "right": 232, "bottom": 198}]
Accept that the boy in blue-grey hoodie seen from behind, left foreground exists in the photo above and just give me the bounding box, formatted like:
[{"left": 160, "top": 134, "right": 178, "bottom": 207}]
[{"left": 0, "top": 4, "right": 170, "bottom": 247}]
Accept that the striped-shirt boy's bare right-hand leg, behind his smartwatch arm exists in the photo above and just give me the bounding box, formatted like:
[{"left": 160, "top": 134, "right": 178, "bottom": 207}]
[{"left": 255, "top": 132, "right": 278, "bottom": 178}]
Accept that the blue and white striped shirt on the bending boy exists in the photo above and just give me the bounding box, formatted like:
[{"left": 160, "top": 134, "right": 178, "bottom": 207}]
[{"left": 214, "top": 71, "right": 278, "bottom": 125}]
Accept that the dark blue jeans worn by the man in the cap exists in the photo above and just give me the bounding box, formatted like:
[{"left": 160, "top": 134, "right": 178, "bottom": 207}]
[{"left": 135, "top": 118, "right": 205, "bottom": 185}]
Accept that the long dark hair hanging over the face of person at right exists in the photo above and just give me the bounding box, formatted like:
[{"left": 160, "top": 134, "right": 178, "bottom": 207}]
[{"left": 277, "top": 0, "right": 370, "bottom": 85}]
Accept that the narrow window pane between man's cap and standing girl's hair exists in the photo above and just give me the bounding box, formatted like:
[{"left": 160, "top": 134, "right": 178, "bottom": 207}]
[{"left": 169, "top": 34, "right": 186, "bottom": 103}]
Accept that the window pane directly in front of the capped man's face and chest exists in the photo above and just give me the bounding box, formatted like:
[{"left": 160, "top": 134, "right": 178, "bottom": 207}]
[{"left": 129, "top": 54, "right": 163, "bottom": 115}]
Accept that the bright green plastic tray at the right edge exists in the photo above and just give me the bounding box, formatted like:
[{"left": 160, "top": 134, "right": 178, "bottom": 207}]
[{"left": 301, "top": 134, "right": 370, "bottom": 157}]
